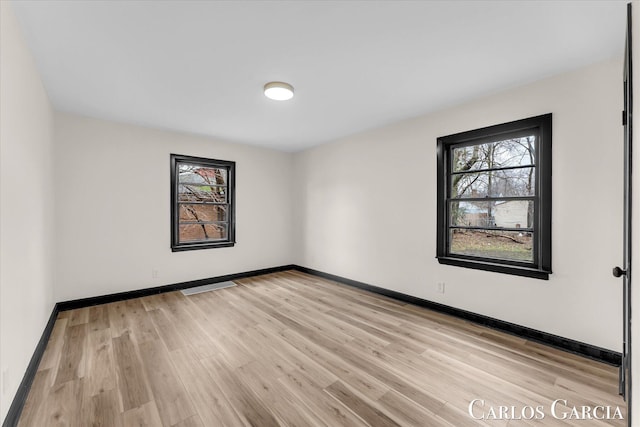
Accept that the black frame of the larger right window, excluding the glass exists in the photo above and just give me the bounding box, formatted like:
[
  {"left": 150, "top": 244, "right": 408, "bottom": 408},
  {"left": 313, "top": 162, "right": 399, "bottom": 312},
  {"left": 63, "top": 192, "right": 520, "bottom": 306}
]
[{"left": 436, "top": 113, "right": 552, "bottom": 280}]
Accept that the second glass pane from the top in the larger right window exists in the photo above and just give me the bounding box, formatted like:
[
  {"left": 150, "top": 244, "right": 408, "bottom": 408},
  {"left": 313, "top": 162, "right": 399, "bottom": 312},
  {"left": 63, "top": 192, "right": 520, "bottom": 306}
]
[{"left": 451, "top": 167, "right": 536, "bottom": 199}]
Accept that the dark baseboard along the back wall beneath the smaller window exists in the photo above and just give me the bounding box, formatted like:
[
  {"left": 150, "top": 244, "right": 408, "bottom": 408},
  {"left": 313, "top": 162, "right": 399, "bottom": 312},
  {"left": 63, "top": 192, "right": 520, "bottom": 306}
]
[{"left": 58, "top": 265, "right": 295, "bottom": 311}]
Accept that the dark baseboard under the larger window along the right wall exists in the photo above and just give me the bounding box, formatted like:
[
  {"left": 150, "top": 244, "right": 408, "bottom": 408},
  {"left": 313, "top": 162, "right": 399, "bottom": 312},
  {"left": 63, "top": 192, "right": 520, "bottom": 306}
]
[{"left": 295, "top": 265, "right": 622, "bottom": 366}]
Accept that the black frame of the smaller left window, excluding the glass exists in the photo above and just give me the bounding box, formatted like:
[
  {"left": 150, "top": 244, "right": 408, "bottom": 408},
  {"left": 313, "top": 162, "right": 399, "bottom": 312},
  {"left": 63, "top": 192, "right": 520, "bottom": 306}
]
[{"left": 171, "top": 154, "right": 236, "bottom": 252}]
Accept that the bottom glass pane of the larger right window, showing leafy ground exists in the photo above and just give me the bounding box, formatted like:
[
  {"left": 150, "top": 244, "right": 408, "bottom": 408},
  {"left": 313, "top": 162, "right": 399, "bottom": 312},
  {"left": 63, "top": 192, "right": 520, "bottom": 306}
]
[{"left": 449, "top": 230, "right": 533, "bottom": 262}]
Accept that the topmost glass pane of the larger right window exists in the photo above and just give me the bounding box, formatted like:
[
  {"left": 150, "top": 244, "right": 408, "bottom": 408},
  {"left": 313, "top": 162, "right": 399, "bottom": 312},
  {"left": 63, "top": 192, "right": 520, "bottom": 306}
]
[{"left": 451, "top": 135, "right": 536, "bottom": 172}]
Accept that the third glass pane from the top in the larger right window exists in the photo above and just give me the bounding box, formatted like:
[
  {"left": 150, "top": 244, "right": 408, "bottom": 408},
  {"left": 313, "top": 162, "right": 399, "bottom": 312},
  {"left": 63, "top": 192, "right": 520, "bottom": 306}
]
[{"left": 449, "top": 200, "right": 533, "bottom": 228}]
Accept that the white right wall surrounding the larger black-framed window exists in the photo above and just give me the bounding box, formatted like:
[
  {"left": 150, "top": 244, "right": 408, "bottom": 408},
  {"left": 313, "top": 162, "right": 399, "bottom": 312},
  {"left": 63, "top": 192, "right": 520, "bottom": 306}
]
[{"left": 294, "top": 61, "right": 622, "bottom": 351}]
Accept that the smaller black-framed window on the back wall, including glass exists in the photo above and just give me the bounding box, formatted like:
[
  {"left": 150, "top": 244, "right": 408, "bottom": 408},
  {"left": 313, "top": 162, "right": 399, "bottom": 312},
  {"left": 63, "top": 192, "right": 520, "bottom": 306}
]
[{"left": 171, "top": 154, "right": 236, "bottom": 252}]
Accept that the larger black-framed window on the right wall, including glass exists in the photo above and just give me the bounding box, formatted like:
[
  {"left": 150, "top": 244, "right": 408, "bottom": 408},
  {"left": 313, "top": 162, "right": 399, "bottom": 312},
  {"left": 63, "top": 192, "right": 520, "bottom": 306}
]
[{"left": 437, "top": 114, "right": 551, "bottom": 280}]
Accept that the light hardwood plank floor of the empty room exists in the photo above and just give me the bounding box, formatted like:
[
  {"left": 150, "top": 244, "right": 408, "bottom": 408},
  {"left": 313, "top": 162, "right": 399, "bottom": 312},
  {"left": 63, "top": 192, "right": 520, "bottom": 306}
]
[{"left": 19, "top": 271, "right": 626, "bottom": 427}]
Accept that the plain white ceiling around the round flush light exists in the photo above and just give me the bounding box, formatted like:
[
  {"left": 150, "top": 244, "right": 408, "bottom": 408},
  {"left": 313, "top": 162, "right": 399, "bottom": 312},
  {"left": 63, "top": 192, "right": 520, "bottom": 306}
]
[{"left": 13, "top": 0, "right": 626, "bottom": 151}]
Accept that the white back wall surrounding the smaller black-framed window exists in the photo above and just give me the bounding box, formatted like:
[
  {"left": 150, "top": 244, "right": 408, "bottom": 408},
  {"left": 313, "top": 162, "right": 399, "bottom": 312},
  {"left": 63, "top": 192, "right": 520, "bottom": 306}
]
[{"left": 55, "top": 113, "right": 292, "bottom": 301}]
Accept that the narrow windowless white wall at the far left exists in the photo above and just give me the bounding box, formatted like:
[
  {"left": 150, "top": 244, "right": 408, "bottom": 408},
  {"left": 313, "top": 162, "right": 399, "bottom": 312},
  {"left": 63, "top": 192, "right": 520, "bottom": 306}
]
[{"left": 0, "top": 1, "right": 54, "bottom": 419}]
